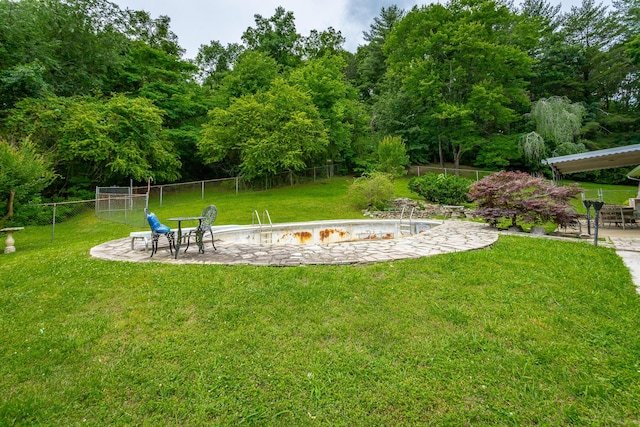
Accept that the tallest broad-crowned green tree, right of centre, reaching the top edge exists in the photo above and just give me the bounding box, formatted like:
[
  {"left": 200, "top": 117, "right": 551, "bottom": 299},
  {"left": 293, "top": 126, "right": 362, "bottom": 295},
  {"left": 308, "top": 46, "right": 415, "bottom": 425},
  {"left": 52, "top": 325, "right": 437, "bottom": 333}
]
[{"left": 384, "top": 0, "right": 537, "bottom": 171}]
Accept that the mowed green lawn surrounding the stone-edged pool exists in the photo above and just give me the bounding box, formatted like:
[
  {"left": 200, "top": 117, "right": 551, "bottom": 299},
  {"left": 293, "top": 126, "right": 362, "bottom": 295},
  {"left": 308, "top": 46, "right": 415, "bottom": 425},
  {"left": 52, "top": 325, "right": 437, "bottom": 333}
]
[{"left": 0, "top": 180, "right": 640, "bottom": 426}]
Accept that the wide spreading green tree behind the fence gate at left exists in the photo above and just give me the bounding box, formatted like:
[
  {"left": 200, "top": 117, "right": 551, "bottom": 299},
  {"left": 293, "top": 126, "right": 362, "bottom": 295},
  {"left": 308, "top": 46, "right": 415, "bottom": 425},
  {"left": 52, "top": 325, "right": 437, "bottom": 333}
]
[{"left": 9, "top": 95, "right": 180, "bottom": 191}]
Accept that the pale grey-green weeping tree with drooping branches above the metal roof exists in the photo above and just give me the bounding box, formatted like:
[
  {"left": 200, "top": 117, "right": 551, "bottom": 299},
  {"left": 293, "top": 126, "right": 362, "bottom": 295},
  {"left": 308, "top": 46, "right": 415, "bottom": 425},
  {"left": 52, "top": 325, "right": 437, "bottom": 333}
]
[{"left": 531, "top": 96, "right": 585, "bottom": 156}]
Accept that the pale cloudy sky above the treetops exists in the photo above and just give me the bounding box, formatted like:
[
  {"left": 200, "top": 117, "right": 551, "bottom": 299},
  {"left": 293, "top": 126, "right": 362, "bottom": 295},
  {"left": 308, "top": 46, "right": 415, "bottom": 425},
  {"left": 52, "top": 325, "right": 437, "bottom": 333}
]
[{"left": 112, "top": 0, "right": 596, "bottom": 58}]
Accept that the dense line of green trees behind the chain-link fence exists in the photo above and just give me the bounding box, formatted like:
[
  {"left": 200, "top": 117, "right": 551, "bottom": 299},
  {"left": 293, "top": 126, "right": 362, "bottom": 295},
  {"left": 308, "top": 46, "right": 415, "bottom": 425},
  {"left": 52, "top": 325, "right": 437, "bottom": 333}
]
[{"left": 0, "top": 0, "right": 640, "bottom": 211}]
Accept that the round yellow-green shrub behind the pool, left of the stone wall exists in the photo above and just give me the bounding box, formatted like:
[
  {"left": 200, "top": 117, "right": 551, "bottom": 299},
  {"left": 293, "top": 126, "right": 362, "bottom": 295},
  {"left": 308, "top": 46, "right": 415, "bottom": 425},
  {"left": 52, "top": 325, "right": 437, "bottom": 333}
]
[{"left": 348, "top": 172, "right": 394, "bottom": 210}]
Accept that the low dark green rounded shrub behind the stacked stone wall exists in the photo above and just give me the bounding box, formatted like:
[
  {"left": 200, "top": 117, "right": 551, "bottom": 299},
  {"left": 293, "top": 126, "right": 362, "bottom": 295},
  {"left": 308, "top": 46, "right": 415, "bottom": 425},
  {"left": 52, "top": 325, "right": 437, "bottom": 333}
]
[{"left": 409, "top": 173, "right": 471, "bottom": 205}]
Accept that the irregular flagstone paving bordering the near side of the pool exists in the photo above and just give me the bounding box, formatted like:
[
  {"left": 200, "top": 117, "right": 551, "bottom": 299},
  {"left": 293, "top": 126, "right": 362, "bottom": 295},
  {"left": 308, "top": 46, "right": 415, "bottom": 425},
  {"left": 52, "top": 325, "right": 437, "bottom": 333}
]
[{"left": 90, "top": 220, "right": 499, "bottom": 267}]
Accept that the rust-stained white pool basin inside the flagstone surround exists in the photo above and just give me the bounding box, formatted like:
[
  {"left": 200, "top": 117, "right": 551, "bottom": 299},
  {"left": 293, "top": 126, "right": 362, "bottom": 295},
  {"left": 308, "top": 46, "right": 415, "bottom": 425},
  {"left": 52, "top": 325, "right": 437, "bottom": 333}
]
[{"left": 215, "top": 219, "right": 441, "bottom": 245}]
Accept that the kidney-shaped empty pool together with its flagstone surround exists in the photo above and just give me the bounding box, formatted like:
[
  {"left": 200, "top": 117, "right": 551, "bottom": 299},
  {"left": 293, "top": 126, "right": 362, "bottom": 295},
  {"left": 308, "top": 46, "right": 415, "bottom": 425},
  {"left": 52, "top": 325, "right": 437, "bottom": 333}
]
[{"left": 91, "top": 219, "right": 498, "bottom": 267}]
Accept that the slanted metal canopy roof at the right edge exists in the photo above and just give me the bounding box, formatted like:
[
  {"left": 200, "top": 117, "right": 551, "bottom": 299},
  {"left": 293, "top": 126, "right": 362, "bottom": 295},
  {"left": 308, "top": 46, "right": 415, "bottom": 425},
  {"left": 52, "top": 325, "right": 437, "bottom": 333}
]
[{"left": 543, "top": 144, "right": 640, "bottom": 175}]
